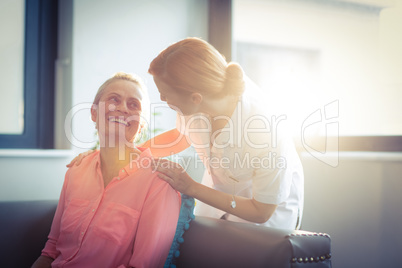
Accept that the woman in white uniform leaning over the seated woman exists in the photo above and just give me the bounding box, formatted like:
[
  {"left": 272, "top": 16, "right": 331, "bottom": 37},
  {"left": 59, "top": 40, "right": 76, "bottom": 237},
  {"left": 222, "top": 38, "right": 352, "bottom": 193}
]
[{"left": 144, "top": 38, "right": 304, "bottom": 229}]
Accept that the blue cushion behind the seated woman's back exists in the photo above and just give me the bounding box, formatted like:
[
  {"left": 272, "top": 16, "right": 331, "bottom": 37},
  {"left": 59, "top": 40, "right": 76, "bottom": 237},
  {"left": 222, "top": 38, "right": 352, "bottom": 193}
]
[{"left": 163, "top": 194, "right": 195, "bottom": 268}]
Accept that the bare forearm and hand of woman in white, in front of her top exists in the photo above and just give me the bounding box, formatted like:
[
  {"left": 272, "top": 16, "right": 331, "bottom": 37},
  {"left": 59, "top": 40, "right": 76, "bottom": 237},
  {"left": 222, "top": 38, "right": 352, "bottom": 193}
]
[{"left": 153, "top": 159, "right": 277, "bottom": 223}]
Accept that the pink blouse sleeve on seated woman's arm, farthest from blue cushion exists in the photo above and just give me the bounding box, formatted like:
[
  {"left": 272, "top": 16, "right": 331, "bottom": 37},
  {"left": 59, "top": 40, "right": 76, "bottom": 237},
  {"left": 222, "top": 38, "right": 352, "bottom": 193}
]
[{"left": 42, "top": 170, "right": 69, "bottom": 259}]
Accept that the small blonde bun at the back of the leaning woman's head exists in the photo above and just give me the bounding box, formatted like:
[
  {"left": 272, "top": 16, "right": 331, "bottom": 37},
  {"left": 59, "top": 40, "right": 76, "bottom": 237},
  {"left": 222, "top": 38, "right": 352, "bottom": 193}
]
[{"left": 223, "top": 62, "right": 244, "bottom": 96}]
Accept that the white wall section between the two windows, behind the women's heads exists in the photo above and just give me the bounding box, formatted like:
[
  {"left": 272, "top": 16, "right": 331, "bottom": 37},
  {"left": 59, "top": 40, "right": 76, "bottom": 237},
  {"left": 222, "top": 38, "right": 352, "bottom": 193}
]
[{"left": 68, "top": 0, "right": 208, "bottom": 149}]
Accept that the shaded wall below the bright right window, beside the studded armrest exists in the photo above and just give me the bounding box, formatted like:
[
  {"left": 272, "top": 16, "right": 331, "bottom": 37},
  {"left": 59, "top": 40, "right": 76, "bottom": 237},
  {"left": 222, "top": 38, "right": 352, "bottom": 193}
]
[{"left": 302, "top": 152, "right": 402, "bottom": 268}]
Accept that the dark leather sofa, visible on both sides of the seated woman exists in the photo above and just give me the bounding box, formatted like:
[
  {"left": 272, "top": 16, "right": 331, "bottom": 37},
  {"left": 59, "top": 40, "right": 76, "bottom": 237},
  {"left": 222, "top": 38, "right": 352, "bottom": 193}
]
[{"left": 0, "top": 200, "right": 331, "bottom": 268}]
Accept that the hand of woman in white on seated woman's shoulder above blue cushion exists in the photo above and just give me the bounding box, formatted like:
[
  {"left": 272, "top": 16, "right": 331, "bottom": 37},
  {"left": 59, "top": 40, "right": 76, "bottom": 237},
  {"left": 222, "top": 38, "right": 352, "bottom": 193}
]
[{"left": 152, "top": 158, "right": 197, "bottom": 196}]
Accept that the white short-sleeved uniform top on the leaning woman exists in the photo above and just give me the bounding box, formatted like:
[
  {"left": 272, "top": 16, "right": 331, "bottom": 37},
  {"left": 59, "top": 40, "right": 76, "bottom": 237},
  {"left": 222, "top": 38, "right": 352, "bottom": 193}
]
[{"left": 176, "top": 78, "right": 304, "bottom": 229}]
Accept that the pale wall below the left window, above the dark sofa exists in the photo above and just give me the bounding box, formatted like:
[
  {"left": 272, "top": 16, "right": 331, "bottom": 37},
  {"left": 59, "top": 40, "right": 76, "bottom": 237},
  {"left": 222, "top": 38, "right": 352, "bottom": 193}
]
[{"left": 0, "top": 150, "right": 74, "bottom": 201}]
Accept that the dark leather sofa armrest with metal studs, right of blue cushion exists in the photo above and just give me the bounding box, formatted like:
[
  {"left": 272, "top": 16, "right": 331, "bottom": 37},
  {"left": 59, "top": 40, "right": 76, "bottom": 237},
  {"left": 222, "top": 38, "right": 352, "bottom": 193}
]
[{"left": 177, "top": 216, "right": 331, "bottom": 268}]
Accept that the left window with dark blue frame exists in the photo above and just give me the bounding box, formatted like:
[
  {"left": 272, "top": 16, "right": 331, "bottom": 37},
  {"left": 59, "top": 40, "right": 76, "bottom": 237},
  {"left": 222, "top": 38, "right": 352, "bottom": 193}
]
[{"left": 0, "top": 0, "right": 58, "bottom": 149}]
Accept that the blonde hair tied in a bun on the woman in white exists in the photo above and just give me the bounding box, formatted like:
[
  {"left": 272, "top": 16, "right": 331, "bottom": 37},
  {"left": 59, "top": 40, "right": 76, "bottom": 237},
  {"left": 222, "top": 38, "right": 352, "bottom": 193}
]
[{"left": 148, "top": 37, "right": 244, "bottom": 97}]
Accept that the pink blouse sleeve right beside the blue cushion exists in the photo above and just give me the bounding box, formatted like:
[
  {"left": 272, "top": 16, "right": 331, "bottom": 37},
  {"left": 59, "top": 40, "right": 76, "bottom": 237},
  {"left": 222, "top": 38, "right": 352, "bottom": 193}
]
[{"left": 130, "top": 176, "right": 181, "bottom": 268}]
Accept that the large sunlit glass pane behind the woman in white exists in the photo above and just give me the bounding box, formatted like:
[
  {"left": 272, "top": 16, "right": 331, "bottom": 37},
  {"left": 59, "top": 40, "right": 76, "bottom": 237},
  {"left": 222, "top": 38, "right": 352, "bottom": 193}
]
[{"left": 233, "top": 0, "right": 402, "bottom": 136}]
